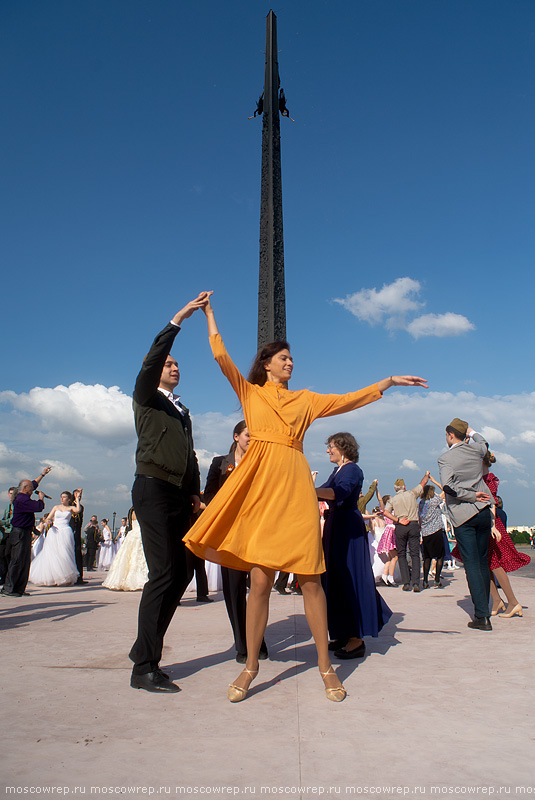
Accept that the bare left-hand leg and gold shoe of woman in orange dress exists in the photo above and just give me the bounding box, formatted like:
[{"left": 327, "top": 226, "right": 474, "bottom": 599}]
[{"left": 229, "top": 567, "right": 275, "bottom": 689}]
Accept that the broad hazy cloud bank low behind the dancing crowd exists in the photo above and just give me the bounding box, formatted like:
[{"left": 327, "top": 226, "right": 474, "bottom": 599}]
[{"left": 0, "top": 389, "right": 535, "bottom": 525}]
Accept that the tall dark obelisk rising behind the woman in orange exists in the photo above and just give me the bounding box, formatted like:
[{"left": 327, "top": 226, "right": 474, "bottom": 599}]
[{"left": 258, "top": 11, "right": 286, "bottom": 348}]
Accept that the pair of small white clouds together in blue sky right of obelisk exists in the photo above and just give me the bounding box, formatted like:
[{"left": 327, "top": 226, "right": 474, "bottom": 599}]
[{"left": 334, "top": 278, "right": 475, "bottom": 339}]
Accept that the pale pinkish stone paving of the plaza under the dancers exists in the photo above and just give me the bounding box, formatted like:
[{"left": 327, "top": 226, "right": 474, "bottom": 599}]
[{"left": 0, "top": 570, "right": 535, "bottom": 798}]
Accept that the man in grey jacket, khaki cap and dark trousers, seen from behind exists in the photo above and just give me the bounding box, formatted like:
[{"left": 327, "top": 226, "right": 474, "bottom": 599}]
[{"left": 438, "top": 417, "right": 494, "bottom": 631}]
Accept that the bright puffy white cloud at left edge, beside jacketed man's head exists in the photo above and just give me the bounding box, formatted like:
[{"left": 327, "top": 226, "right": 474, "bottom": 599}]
[{"left": 0, "top": 383, "right": 134, "bottom": 442}]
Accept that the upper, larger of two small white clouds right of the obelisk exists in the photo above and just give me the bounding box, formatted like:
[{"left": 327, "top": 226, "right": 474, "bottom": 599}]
[{"left": 334, "top": 278, "right": 423, "bottom": 325}]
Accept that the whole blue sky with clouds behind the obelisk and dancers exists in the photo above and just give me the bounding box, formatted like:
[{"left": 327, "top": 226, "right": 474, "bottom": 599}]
[{"left": 0, "top": 0, "right": 535, "bottom": 525}]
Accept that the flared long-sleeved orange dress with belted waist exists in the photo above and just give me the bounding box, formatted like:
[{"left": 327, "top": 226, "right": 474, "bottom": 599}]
[{"left": 184, "top": 334, "right": 382, "bottom": 575}]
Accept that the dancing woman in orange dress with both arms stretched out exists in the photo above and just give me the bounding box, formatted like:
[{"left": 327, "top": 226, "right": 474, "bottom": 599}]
[{"left": 185, "top": 293, "right": 427, "bottom": 702}]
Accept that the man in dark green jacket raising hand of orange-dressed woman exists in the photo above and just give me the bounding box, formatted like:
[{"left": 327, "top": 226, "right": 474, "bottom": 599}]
[{"left": 130, "top": 292, "right": 208, "bottom": 692}]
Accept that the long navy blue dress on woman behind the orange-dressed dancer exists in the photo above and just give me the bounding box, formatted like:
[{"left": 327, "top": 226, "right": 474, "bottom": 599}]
[{"left": 321, "top": 461, "right": 392, "bottom": 639}]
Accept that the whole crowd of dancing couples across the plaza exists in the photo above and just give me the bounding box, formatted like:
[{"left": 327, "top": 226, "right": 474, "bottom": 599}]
[{"left": 0, "top": 292, "right": 530, "bottom": 702}]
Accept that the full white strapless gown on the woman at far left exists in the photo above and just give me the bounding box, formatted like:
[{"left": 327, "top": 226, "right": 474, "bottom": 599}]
[{"left": 29, "top": 511, "right": 78, "bottom": 586}]
